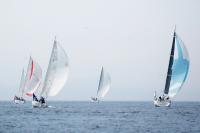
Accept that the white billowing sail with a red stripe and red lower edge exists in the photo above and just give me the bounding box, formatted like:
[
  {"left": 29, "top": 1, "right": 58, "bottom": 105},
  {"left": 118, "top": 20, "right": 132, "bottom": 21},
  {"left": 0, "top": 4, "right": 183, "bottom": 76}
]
[{"left": 25, "top": 57, "right": 42, "bottom": 96}]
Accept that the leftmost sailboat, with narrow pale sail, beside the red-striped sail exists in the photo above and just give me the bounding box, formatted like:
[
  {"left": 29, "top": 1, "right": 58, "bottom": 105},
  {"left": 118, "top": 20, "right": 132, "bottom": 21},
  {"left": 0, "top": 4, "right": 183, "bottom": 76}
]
[{"left": 14, "top": 69, "right": 25, "bottom": 104}]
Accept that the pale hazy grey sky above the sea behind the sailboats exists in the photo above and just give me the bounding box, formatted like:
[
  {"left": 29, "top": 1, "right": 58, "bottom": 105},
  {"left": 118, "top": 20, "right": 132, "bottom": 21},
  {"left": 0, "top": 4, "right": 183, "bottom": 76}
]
[{"left": 0, "top": 0, "right": 200, "bottom": 101}]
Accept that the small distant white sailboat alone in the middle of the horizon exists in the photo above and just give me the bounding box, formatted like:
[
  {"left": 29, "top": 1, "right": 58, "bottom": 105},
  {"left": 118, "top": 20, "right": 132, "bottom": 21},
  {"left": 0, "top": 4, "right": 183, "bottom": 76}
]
[{"left": 91, "top": 67, "right": 111, "bottom": 102}]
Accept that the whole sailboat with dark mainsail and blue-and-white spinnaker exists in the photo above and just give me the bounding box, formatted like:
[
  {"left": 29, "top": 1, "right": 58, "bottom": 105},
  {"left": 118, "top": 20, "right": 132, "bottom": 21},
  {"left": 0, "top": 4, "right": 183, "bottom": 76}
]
[{"left": 154, "top": 30, "right": 190, "bottom": 107}]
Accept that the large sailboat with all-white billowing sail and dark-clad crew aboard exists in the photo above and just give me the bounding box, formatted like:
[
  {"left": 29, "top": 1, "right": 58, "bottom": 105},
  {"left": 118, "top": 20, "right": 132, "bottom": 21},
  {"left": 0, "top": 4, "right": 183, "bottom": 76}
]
[{"left": 32, "top": 38, "right": 69, "bottom": 107}]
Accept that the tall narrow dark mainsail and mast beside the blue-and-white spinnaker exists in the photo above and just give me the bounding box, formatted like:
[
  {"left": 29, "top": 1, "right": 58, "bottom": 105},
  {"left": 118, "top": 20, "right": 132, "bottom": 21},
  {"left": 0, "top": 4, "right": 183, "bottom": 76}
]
[{"left": 164, "top": 30, "right": 176, "bottom": 94}]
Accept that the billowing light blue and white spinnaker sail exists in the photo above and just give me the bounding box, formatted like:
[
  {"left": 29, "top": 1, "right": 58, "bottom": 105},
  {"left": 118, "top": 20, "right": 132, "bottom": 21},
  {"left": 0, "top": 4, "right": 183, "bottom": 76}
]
[{"left": 168, "top": 35, "right": 190, "bottom": 97}]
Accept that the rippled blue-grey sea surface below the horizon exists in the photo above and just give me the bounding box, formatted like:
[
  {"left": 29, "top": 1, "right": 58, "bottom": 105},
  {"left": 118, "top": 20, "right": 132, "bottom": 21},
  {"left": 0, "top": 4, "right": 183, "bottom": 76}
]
[{"left": 0, "top": 102, "right": 200, "bottom": 133}]
